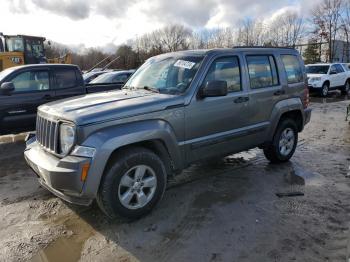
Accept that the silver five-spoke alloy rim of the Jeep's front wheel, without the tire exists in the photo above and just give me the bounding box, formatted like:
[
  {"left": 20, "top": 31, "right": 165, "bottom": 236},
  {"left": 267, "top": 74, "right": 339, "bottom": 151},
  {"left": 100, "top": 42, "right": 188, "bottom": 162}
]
[{"left": 118, "top": 165, "right": 157, "bottom": 209}]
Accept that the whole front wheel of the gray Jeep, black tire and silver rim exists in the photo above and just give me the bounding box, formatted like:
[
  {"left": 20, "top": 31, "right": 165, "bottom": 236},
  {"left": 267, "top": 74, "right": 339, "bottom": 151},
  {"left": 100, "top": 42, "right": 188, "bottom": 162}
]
[{"left": 96, "top": 147, "right": 167, "bottom": 220}]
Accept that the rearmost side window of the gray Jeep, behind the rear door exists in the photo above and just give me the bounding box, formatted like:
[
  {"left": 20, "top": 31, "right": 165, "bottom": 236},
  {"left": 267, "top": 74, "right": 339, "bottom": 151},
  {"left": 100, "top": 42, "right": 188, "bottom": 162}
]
[{"left": 281, "top": 55, "right": 304, "bottom": 84}]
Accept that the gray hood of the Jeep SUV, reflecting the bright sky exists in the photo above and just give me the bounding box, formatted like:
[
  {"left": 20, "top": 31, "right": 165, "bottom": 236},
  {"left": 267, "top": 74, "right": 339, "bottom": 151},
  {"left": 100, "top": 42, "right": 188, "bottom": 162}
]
[{"left": 38, "top": 90, "right": 183, "bottom": 125}]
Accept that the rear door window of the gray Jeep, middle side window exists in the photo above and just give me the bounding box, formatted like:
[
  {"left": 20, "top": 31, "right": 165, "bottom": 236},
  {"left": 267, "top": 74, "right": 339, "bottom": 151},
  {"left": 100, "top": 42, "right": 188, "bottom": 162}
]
[{"left": 247, "top": 55, "right": 279, "bottom": 89}]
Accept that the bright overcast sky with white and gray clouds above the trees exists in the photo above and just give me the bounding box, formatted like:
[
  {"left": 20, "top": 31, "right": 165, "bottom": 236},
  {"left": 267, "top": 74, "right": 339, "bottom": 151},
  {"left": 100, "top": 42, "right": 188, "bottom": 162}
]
[{"left": 0, "top": 0, "right": 315, "bottom": 50}]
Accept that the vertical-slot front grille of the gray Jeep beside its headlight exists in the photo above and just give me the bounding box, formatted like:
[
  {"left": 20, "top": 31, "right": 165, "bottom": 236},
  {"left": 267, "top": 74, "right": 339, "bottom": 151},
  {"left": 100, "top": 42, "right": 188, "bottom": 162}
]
[{"left": 36, "top": 115, "right": 58, "bottom": 153}]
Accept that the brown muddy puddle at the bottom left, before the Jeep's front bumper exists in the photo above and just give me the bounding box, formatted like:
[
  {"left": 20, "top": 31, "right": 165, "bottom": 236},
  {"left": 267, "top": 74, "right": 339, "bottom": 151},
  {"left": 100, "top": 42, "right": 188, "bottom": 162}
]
[{"left": 31, "top": 216, "right": 94, "bottom": 262}]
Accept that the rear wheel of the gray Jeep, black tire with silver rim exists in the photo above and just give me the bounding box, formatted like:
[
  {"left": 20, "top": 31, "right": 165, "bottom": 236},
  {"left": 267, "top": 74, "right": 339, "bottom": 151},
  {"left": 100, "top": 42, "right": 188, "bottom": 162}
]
[{"left": 264, "top": 118, "right": 298, "bottom": 163}]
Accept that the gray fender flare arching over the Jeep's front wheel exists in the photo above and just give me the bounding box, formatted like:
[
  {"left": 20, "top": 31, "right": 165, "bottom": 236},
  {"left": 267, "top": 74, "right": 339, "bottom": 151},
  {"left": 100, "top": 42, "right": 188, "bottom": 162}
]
[{"left": 79, "top": 120, "right": 183, "bottom": 197}]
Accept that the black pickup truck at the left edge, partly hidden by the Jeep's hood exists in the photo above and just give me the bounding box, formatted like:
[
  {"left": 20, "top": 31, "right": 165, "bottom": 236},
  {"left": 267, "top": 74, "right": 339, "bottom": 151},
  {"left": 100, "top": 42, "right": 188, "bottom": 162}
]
[{"left": 0, "top": 64, "right": 125, "bottom": 134}]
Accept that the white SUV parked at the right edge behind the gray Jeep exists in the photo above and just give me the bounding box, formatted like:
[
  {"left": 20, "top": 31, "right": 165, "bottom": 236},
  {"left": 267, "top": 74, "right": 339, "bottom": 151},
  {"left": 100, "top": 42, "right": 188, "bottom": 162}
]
[{"left": 306, "top": 63, "right": 350, "bottom": 97}]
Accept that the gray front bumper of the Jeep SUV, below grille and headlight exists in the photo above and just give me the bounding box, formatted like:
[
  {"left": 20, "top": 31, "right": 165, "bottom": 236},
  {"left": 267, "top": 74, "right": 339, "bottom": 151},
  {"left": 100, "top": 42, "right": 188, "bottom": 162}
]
[{"left": 24, "top": 142, "right": 93, "bottom": 205}]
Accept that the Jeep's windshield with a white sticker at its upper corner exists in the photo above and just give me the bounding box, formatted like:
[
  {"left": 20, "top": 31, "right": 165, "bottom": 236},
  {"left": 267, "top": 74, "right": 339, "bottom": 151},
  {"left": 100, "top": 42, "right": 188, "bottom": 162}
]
[{"left": 124, "top": 56, "right": 203, "bottom": 94}]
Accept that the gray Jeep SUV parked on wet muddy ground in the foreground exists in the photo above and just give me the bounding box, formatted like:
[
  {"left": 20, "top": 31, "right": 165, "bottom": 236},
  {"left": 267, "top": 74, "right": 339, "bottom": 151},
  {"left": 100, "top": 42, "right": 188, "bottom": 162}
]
[{"left": 24, "top": 48, "right": 311, "bottom": 218}]
